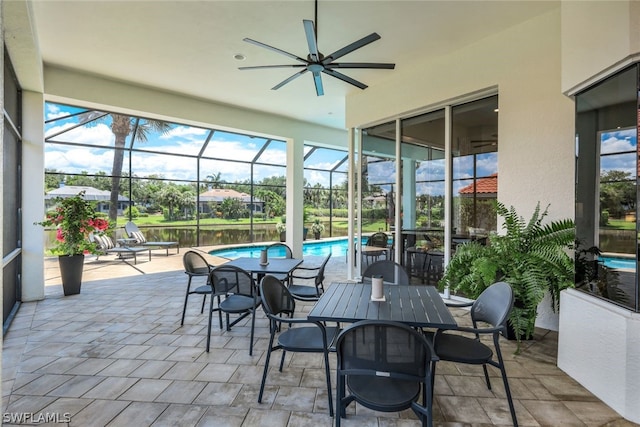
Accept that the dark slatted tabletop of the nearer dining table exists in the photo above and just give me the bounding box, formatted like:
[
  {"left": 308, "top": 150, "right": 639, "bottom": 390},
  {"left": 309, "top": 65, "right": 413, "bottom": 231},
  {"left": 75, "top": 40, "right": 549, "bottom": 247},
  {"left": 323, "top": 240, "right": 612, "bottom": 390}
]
[{"left": 307, "top": 282, "right": 457, "bottom": 329}]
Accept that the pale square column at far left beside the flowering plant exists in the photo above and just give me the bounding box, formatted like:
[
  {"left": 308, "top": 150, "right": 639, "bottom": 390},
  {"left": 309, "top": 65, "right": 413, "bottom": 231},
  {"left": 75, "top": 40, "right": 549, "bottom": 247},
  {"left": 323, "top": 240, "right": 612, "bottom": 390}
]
[{"left": 22, "top": 90, "right": 44, "bottom": 302}]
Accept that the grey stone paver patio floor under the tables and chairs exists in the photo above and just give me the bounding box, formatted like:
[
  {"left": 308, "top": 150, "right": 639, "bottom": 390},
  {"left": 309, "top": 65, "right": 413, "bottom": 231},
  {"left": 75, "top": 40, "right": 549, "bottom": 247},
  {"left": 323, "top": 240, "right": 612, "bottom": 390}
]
[{"left": 2, "top": 249, "right": 635, "bottom": 427}]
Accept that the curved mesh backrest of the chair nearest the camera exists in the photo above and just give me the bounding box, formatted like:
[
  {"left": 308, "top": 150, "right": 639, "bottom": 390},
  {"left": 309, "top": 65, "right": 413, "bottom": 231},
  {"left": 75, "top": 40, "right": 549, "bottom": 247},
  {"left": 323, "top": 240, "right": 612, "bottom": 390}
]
[{"left": 336, "top": 320, "right": 435, "bottom": 381}]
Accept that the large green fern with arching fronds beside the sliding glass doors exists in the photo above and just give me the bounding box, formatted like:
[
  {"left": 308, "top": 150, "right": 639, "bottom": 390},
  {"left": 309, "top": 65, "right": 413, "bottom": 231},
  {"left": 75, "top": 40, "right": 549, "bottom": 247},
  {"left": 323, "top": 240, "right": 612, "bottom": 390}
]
[{"left": 439, "top": 203, "right": 575, "bottom": 345}]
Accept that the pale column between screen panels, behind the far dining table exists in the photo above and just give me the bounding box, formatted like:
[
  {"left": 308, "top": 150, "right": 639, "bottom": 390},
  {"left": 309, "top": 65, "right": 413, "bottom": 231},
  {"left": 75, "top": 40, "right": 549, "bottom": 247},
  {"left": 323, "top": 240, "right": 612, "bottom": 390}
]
[{"left": 286, "top": 139, "right": 305, "bottom": 258}]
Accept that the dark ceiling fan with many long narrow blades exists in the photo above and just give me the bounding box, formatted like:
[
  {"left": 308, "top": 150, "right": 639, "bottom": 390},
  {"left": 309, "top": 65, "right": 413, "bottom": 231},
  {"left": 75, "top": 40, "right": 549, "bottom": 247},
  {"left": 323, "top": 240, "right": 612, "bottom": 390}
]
[{"left": 238, "top": 0, "right": 396, "bottom": 96}]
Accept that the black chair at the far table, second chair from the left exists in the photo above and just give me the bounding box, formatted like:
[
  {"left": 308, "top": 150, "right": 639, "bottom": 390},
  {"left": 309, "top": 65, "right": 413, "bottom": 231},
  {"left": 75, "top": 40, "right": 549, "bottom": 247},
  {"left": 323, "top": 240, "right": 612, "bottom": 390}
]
[{"left": 207, "top": 264, "right": 260, "bottom": 356}]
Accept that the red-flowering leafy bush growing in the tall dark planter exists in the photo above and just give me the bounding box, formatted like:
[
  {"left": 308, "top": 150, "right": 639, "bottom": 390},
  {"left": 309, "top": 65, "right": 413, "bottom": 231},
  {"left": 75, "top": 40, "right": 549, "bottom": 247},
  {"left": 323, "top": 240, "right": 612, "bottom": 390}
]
[{"left": 36, "top": 191, "right": 109, "bottom": 255}]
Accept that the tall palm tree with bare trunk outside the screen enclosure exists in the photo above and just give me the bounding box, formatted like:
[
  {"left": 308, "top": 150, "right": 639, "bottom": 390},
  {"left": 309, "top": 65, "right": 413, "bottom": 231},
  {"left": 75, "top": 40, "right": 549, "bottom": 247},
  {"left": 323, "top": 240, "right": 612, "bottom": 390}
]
[{"left": 80, "top": 110, "right": 171, "bottom": 224}]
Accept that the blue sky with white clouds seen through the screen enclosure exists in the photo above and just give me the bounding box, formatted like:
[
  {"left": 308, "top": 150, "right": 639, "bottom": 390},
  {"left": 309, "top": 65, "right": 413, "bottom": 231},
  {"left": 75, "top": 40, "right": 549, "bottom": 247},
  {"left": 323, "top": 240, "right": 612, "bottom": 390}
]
[{"left": 45, "top": 103, "right": 346, "bottom": 186}]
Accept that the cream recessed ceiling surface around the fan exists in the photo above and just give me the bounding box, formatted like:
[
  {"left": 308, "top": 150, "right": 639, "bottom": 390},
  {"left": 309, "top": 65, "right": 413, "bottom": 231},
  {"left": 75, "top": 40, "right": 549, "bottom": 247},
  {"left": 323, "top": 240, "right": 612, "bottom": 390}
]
[{"left": 28, "top": 0, "right": 558, "bottom": 129}]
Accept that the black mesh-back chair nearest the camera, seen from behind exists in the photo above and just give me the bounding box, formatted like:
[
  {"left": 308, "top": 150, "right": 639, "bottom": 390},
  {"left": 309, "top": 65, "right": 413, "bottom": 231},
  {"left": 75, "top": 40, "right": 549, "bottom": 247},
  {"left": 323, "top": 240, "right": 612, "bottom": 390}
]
[{"left": 336, "top": 320, "right": 437, "bottom": 427}]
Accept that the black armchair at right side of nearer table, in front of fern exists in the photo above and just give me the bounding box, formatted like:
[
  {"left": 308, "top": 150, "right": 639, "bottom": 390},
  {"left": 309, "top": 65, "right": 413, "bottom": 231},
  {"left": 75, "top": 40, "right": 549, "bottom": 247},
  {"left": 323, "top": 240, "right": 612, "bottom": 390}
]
[{"left": 431, "top": 282, "right": 518, "bottom": 427}]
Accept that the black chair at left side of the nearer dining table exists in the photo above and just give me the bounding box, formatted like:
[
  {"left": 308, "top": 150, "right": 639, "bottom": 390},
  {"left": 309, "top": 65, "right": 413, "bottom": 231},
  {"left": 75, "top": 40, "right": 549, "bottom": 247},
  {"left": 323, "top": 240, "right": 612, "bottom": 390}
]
[{"left": 258, "top": 275, "right": 338, "bottom": 416}]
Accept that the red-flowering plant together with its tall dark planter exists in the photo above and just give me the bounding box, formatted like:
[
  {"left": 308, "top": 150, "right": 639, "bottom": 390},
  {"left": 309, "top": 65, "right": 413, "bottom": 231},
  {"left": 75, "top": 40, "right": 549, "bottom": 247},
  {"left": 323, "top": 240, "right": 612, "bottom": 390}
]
[{"left": 36, "top": 191, "right": 109, "bottom": 295}]
